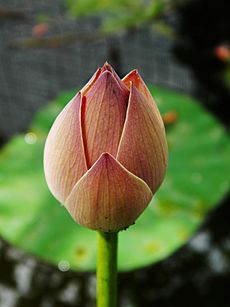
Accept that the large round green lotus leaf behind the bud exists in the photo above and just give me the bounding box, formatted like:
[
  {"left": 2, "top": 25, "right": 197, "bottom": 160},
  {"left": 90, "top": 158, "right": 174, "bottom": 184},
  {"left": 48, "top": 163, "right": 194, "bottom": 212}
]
[{"left": 0, "top": 87, "right": 230, "bottom": 271}]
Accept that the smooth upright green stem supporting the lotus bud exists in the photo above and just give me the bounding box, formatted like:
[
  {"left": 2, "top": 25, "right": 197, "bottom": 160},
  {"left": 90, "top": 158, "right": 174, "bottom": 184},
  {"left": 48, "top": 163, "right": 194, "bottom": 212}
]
[{"left": 97, "top": 231, "right": 118, "bottom": 307}]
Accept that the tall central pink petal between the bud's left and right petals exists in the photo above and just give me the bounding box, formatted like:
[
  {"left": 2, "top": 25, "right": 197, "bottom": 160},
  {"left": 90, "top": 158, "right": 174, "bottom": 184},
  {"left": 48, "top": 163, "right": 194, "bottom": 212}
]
[{"left": 82, "top": 71, "right": 129, "bottom": 167}]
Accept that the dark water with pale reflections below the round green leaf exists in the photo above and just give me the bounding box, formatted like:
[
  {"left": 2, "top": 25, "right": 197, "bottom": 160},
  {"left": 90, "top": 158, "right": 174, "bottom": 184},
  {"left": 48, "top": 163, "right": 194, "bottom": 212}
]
[{"left": 0, "top": 198, "right": 230, "bottom": 307}]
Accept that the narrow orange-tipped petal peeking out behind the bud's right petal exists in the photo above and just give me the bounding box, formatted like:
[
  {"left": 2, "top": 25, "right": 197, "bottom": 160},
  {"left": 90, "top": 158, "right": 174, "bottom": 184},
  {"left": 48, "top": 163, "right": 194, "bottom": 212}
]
[{"left": 122, "top": 69, "right": 164, "bottom": 127}]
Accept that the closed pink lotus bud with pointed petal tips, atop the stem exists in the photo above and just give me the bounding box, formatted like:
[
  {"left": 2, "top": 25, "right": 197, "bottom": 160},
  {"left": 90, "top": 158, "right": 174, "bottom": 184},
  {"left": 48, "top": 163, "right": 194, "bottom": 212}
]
[{"left": 44, "top": 63, "right": 168, "bottom": 232}]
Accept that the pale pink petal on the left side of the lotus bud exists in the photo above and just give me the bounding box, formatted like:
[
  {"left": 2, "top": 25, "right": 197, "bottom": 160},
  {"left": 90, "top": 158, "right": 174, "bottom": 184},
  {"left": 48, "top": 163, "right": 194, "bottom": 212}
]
[{"left": 44, "top": 93, "right": 87, "bottom": 202}]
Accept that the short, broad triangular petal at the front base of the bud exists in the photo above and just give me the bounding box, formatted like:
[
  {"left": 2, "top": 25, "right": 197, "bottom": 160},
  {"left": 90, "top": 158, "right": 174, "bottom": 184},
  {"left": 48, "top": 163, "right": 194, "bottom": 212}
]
[{"left": 65, "top": 153, "right": 152, "bottom": 232}]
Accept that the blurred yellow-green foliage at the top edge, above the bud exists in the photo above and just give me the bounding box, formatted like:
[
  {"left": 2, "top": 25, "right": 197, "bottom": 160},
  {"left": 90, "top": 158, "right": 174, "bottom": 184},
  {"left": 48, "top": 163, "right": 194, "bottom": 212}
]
[{"left": 66, "top": 0, "right": 170, "bottom": 32}]
